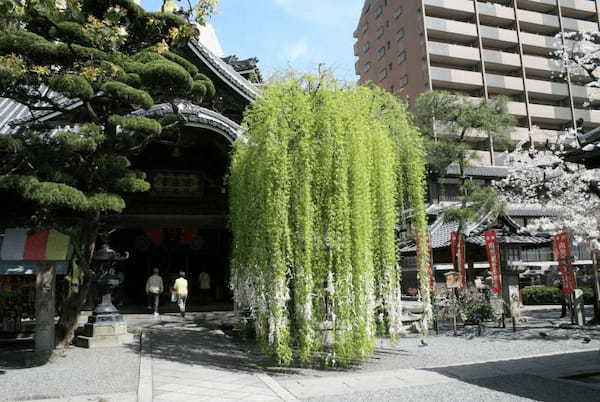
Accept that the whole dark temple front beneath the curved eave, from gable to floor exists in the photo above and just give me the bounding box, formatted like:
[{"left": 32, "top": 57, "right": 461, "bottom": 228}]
[{"left": 101, "top": 119, "right": 232, "bottom": 312}]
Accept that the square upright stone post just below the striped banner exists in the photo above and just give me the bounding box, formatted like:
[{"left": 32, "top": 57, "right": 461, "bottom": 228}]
[{"left": 35, "top": 264, "right": 56, "bottom": 353}]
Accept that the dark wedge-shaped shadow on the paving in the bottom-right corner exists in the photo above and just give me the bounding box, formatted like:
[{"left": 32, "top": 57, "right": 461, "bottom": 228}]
[{"left": 424, "top": 351, "right": 600, "bottom": 402}]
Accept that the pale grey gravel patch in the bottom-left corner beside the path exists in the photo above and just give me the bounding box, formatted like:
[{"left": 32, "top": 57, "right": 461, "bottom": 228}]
[{"left": 0, "top": 343, "right": 140, "bottom": 401}]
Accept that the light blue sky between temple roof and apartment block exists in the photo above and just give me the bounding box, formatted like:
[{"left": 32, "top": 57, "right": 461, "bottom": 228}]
[{"left": 142, "top": 0, "right": 363, "bottom": 81}]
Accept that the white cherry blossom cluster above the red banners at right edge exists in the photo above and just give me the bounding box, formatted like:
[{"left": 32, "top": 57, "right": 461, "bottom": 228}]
[{"left": 496, "top": 131, "right": 600, "bottom": 247}]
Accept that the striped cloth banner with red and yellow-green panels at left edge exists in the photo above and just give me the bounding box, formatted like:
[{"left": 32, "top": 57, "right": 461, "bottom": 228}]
[{"left": 0, "top": 228, "right": 70, "bottom": 261}]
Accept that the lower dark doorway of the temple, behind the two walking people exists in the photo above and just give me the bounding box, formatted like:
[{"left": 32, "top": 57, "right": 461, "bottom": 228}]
[{"left": 111, "top": 227, "right": 231, "bottom": 311}]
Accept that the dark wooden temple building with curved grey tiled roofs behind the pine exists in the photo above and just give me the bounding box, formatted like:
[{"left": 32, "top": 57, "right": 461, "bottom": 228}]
[{"left": 0, "top": 31, "right": 260, "bottom": 330}]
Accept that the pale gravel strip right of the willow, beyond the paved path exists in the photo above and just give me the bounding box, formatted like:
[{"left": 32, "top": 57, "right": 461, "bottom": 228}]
[{"left": 270, "top": 307, "right": 600, "bottom": 377}]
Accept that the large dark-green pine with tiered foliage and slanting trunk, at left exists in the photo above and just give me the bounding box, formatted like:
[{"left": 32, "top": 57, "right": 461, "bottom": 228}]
[{"left": 0, "top": 0, "right": 215, "bottom": 345}]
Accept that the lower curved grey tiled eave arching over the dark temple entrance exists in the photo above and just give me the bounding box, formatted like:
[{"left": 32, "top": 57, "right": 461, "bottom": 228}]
[{"left": 132, "top": 102, "right": 241, "bottom": 142}]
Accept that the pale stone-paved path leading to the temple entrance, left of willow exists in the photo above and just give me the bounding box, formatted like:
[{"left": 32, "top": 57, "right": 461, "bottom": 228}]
[{"left": 138, "top": 319, "right": 295, "bottom": 401}]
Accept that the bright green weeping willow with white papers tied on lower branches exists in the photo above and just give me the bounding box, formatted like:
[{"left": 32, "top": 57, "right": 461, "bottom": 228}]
[{"left": 231, "top": 75, "right": 426, "bottom": 365}]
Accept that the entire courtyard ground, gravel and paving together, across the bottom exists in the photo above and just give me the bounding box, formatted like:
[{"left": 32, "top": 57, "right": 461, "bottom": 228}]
[{"left": 0, "top": 308, "right": 600, "bottom": 402}]
